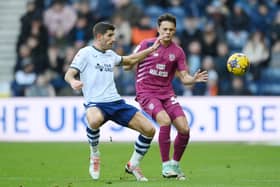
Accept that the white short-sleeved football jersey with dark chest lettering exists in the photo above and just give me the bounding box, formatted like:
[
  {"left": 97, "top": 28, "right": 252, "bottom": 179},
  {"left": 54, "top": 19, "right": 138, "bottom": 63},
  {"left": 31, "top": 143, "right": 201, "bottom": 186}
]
[{"left": 70, "top": 46, "right": 122, "bottom": 103}]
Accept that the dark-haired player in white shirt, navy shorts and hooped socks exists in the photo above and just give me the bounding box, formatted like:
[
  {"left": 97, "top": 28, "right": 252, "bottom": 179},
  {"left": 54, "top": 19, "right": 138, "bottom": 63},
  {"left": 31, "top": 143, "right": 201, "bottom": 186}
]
[{"left": 65, "top": 22, "right": 160, "bottom": 181}]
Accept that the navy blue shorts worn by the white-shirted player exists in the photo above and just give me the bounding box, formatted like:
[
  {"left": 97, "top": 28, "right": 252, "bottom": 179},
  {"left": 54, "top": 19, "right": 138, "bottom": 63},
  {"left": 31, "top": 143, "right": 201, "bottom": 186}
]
[{"left": 84, "top": 99, "right": 138, "bottom": 127}]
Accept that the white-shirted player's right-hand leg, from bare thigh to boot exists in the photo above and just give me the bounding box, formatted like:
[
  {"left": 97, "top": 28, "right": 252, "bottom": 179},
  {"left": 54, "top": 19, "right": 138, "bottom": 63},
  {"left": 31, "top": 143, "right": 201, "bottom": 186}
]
[{"left": 126, "top": 112, "right": 155, "bottom": 181}]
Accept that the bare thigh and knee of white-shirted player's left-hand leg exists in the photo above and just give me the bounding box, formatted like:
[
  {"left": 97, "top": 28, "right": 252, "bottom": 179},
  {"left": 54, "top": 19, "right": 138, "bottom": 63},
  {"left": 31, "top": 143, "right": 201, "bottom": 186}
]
[{"left": 86, "top": 107, "right": 104, "bottom": 128}]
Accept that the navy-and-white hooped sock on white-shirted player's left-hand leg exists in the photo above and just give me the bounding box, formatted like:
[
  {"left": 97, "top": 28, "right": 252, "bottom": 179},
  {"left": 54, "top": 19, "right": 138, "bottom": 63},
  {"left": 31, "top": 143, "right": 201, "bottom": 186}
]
[{"left": 87, "top": 127, "right": 100, "bottom": 154}]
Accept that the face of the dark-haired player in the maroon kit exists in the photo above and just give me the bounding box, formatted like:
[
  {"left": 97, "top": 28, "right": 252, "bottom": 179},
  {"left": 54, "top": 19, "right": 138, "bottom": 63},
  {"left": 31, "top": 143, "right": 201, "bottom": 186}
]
[{"left": 158, "top": 21, "right": 176, "bottom": 42}]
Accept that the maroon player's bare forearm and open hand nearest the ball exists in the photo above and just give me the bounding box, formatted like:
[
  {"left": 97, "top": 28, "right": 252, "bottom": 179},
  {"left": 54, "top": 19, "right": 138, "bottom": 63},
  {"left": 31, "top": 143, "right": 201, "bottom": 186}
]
[{"left": 178, "top": 69, "right": 208, "bottom": 85}]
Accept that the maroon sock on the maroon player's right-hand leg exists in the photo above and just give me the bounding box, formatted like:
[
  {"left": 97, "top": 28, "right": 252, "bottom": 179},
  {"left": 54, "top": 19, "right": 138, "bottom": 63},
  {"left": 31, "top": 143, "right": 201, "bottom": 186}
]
[{"left": 173, "top": 133, "right": 190, "bottom": 161}]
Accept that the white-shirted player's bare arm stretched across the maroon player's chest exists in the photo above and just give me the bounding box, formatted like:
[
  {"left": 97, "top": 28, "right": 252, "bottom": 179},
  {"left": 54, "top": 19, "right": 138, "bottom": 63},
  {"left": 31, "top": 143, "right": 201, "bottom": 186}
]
[{"left": 122, "top": 37, "right": 161, "bottom": 66}]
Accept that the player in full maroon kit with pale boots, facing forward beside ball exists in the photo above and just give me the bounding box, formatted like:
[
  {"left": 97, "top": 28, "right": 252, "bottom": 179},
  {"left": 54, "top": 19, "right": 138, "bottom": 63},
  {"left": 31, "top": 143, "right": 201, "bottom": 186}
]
[{"left": 130, "top": 14, "right": 208, "bottom": 180}]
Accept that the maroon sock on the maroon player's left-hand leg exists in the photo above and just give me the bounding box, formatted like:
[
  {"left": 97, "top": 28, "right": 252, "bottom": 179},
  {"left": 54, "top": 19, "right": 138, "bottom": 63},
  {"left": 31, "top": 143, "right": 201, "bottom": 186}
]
[{"left": 158, "top": 125, "right": 171, "bottom": 162}]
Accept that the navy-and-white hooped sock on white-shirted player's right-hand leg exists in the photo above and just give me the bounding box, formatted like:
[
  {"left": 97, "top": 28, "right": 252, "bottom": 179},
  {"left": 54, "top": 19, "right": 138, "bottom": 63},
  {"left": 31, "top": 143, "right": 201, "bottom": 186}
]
[{"left": 130, "top": 134, "right": 153, "bottom": 166}]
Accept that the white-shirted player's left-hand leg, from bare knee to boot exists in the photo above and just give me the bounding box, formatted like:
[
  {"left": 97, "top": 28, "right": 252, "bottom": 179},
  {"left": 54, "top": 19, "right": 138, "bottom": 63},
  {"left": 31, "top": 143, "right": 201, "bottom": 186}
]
[{"left": 86, "top": 107, "right": 104, "bottom": 180}]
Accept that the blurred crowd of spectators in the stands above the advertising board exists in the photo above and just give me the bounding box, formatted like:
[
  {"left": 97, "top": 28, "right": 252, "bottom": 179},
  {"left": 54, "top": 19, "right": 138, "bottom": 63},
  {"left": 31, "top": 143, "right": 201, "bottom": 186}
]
[{"left": 0, "top": 0, "right": 280, "bottom": 97}]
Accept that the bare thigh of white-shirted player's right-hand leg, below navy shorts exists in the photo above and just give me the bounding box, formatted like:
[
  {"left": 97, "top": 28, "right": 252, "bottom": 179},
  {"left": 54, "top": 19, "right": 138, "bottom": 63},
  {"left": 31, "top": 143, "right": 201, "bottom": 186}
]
[{"left": 128, "top": 112, "right": 155, "bottom": 137}]
